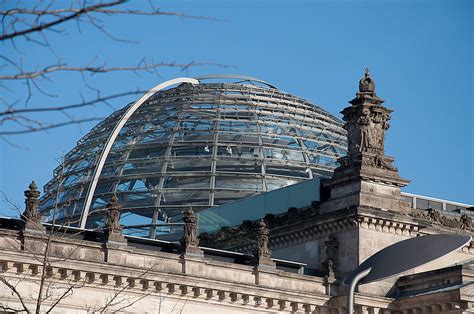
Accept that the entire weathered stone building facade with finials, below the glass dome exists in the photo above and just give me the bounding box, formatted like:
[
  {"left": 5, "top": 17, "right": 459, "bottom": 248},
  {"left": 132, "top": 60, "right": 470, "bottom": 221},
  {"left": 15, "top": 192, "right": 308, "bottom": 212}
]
[{"left": 0, "top": 71, "right": 474, "bottom": 314}]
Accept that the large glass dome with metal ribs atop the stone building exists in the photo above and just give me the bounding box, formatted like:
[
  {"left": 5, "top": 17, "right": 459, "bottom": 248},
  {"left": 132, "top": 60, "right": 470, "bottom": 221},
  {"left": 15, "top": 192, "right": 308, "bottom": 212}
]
[{"left": 40, "top": 76, "right": 347, "bottom": 238}]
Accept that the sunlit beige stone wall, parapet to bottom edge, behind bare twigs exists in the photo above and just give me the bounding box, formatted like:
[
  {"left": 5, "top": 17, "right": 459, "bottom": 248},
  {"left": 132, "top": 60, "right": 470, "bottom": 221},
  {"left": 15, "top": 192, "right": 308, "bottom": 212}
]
[{"left": 0, "top": 229, "right": 336, "bottom": 313}]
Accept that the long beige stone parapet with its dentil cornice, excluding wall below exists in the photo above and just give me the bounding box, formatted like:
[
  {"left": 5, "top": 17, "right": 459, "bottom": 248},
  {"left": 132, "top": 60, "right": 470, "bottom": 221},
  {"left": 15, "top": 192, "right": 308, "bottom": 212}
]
[{"left": 0, "top": 229, "right": 340, "bottom": 311}]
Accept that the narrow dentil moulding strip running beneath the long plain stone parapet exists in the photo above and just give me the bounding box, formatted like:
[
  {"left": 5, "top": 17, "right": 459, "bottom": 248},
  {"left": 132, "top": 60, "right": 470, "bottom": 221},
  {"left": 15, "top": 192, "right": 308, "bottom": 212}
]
[{"left": 0, "top": 256, "right": 330, "bottom": 312}]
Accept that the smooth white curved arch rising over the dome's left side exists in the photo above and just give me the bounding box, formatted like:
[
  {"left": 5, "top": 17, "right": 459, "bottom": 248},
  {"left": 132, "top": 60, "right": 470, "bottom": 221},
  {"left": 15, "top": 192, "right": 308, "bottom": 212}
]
[{"left": 79, "top": 77, "right": 199, "bottom": 229}]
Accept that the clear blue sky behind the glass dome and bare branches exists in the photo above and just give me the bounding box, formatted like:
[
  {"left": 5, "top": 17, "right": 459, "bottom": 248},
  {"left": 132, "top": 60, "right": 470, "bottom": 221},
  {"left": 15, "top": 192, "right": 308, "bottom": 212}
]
[{"left": 0, "top": 0, "right": 474, "bottom": 214}]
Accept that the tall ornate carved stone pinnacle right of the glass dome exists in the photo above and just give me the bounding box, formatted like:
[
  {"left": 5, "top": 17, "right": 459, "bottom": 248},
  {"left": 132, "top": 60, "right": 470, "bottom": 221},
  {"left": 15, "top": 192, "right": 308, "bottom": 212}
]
[{"left": 320, "top": 69, "right": 410, "bottom": 213}]
